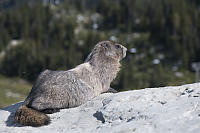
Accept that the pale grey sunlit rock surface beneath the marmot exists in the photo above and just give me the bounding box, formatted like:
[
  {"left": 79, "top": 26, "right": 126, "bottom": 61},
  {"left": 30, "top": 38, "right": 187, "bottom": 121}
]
[{"left": 0, "top": 83, "right": 200, "bottom": 133}]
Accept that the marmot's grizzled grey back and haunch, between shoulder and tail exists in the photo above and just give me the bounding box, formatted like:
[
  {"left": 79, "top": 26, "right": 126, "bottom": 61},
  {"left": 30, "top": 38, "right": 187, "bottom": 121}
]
[{"left": 25, "top": 70, "right": 94, "bottom": 110}]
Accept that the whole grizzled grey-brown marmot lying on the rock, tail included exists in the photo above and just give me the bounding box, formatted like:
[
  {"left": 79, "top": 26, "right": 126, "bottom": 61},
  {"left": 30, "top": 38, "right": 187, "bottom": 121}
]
[{"left": 14, "top": 41, "right": 127, "bottom": 126}]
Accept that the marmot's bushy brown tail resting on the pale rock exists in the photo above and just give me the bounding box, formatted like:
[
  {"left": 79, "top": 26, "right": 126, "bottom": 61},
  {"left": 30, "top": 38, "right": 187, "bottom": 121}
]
[{"left": 15, "top": 105, "right": 50, "bottom": 127}]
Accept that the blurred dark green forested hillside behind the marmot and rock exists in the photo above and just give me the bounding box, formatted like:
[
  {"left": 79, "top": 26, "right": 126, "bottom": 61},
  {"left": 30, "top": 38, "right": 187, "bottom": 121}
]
[{"left": 0, "top": 0, "right": 200, "bottom": 107}]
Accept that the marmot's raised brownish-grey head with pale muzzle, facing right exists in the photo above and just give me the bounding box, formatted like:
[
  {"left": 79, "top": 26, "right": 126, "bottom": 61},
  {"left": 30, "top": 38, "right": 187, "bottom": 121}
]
[{"left": 86, "top": 41, "right": 127, "bottom": 61}]
